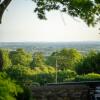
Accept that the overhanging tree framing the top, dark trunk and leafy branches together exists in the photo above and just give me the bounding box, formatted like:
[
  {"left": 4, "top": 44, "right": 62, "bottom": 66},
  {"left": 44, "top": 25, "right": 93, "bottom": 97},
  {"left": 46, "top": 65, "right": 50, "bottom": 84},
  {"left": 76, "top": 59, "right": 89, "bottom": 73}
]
[{"left": 0, "top": 0, "right": 100, "bottom": 25}]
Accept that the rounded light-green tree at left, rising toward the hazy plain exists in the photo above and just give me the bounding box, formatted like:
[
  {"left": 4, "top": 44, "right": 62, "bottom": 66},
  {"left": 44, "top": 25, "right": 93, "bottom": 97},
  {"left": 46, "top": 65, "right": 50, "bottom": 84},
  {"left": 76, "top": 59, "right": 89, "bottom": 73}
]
[{"left": 10, "top": 48, "right": 32, "bottom": 66}]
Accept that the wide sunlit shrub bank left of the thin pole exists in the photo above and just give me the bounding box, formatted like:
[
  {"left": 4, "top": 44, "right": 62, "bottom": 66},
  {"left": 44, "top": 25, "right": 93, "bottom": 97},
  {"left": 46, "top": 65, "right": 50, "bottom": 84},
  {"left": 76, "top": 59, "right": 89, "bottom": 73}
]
[{"left": 6, "top": 65, "right": 55, "bottom": 87}]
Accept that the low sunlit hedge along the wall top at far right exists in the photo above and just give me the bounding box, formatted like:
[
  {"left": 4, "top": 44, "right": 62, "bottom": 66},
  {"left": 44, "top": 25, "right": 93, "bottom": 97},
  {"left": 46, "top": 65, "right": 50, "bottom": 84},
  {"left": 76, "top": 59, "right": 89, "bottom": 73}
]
[{"left": 75, "top": 73, "right": 100, "bottom": 81}]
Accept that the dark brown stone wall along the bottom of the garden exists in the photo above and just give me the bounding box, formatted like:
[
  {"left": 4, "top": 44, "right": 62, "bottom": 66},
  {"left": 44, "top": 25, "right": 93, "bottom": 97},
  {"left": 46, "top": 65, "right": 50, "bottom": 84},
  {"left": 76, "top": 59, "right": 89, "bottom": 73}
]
[{"left": 32, "top": 85, "right": 89, "bottom": 100}]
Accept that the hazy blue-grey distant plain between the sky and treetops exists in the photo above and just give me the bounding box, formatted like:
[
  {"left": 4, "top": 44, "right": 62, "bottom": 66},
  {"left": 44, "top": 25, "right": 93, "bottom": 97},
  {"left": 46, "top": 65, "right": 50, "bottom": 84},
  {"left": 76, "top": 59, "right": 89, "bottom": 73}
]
[{"left": 0, "top": 41, "right": 100, "bottom": 55}]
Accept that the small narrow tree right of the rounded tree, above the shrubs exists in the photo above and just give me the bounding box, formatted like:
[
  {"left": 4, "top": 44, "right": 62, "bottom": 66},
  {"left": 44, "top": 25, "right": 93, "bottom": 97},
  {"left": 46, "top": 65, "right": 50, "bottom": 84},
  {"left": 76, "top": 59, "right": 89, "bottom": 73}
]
[{"left": 31, "top": 52, "right": 45, "bottom": 67}]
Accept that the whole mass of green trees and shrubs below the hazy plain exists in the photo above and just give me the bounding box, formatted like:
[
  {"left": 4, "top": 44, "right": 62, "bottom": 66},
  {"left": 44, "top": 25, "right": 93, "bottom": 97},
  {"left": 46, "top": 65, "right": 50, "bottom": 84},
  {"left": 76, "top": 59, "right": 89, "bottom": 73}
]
[{"left": 0, "top": 48, "right": 100, "bottom": 100}]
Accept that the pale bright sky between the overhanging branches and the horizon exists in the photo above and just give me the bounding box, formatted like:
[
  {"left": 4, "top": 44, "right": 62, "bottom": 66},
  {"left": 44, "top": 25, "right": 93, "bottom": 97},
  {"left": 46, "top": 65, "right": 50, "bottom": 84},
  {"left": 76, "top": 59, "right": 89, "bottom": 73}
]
[{"left": 0, "top": 0, "right": 100, "bottom": 42}]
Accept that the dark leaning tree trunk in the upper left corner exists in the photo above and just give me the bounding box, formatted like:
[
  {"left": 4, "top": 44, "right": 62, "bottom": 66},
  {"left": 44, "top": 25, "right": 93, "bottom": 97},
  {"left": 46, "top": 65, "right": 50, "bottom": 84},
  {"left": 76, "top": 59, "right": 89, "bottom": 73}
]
[{"left": 0, "top": 0, "right": 12, "bottom": 24}]
